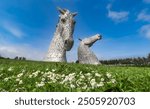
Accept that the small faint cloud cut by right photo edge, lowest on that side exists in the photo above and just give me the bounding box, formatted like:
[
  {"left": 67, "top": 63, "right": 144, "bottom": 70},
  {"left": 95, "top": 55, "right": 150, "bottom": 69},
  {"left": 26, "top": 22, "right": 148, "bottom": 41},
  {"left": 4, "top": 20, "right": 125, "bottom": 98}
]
[{"left": 139, "top": 24, "right": 150, "bottom": 39}]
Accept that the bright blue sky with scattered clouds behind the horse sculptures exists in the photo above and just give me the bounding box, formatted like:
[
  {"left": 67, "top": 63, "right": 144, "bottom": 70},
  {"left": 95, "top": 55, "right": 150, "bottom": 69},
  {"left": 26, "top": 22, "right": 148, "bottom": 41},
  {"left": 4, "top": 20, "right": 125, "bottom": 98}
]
[{"left": 0, "top": 0, "right": 150, "bottom": 61}]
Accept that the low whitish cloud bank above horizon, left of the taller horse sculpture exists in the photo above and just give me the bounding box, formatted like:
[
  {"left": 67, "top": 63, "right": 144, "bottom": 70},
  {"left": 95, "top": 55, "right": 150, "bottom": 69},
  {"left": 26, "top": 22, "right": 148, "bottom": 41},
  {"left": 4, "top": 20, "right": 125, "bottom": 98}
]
[{"left": 0, "top": 44, "right": 45, "bottom": 60}]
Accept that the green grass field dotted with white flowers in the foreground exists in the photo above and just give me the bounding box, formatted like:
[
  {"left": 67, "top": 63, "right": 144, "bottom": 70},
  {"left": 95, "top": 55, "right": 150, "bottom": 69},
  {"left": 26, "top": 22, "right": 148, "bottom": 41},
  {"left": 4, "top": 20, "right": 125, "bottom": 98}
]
[{"left": 0, "top": 59, "right": 150, "bottom": 92}]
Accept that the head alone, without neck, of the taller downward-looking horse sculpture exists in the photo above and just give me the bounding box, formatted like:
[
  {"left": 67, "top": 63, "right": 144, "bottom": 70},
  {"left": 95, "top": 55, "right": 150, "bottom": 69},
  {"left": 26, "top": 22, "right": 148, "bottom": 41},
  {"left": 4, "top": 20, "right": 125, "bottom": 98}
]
[{"left": 58, "top": 8, "right": 77, "bottom": 51}]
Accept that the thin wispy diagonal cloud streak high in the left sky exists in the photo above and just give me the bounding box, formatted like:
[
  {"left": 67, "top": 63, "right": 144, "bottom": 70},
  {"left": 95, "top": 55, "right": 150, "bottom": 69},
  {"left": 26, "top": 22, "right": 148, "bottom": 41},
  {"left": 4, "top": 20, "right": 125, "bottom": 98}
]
[{"left": 3, "top": 22, "right": 25, "bottom": 38}]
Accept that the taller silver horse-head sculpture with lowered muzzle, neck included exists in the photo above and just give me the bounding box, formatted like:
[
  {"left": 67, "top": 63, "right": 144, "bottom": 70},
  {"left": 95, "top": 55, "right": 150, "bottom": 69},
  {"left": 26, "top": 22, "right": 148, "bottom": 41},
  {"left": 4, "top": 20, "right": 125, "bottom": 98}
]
[{"left": 45, "top": 8, "right": 77, "bottom": 62}]
